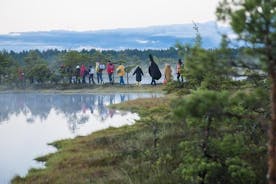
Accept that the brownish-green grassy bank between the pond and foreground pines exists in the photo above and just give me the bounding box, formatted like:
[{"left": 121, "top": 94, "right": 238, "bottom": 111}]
[{"left": 12, "top": 94, "right": 183, "bottom": 184}]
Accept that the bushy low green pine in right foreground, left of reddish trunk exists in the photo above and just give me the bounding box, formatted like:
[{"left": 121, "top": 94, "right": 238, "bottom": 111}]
[{"left": 174, "top": 90, "right": 268, "bottom": 183}]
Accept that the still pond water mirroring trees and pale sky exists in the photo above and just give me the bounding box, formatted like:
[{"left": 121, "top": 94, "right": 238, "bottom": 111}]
[{"left": 0, "top": 93, "right": 158, "bottom": 184}]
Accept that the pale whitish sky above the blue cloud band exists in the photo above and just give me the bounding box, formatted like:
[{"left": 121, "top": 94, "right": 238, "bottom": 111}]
[{"left": 0, "top": 0, "right": 219, "bottom": 34}]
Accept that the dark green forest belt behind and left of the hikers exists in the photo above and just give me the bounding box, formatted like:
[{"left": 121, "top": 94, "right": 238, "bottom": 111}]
[{"left": 0, "top": 47, "right": 178, "bottom": 84}]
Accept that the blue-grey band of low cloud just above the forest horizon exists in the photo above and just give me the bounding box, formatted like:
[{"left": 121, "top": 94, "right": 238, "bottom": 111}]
[{"left": 0, "top": 22, "right": 235, "bottom": 51}]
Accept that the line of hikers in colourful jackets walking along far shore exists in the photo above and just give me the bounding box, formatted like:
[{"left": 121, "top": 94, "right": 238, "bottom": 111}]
[{"left": 73, "top": 55, "right": 183, "bottom": 86}]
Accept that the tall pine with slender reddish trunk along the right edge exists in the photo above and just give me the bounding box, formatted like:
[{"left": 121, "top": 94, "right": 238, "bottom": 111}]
[{"left": 217, "top": 0, "right": 276, "bottom": 184}]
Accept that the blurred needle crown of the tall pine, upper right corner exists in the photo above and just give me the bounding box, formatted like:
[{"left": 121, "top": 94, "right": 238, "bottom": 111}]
[{"left": 216, "top": 0, "right": 276, "bottom": 65}]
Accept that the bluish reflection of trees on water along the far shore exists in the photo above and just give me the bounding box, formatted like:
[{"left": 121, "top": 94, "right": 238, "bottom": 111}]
[{"left": 0, "top": 93, "right": 149, "bottom": 132}]
